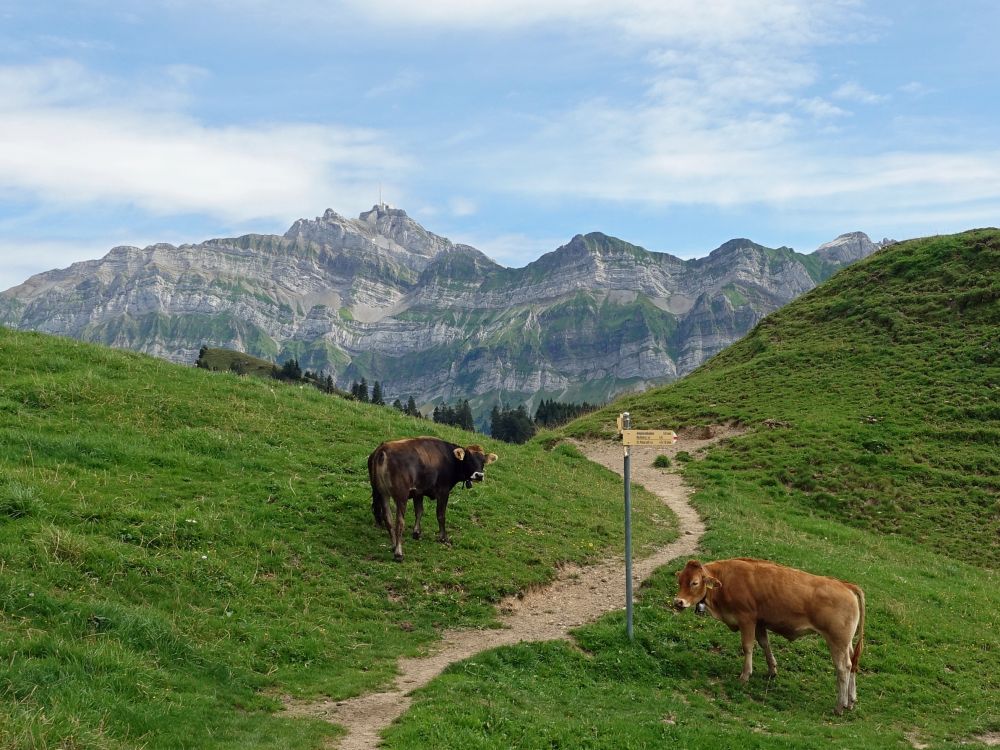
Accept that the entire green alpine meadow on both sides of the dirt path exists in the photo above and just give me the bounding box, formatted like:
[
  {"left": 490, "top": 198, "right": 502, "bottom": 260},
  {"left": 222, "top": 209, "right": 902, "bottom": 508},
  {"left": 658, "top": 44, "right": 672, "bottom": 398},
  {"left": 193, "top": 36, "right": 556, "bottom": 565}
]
[{"left": 0, "top": 229, "right": 1000, "bottom": 749}]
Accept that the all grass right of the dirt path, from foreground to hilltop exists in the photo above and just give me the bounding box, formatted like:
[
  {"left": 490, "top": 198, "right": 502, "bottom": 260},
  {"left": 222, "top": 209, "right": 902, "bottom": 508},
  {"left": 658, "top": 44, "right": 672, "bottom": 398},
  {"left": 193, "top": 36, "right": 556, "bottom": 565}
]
[{"left": 389, "top": 230, "right": 1000, "bottom": 748}]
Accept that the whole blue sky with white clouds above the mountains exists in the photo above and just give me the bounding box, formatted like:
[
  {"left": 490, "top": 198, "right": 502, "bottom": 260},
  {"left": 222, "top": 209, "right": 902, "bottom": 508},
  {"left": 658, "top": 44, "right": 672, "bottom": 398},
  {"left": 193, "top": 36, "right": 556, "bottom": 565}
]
[{"left": 0, "top": 0, "right": 1000, "bottom": 289}]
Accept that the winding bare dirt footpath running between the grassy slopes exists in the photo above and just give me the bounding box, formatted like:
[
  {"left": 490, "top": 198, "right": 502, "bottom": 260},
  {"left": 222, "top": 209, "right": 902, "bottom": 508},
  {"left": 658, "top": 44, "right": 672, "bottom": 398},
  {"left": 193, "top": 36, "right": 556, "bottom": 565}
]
[{"left": 284, "top": 426, "right": 742, "bottom": 750}]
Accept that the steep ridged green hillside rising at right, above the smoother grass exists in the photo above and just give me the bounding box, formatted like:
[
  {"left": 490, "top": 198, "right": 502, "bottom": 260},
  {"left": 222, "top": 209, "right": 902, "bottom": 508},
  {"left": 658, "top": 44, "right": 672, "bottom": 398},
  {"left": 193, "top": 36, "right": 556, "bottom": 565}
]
[{"left": 567, "top": 230, "right": 1000, "bottom": 568}]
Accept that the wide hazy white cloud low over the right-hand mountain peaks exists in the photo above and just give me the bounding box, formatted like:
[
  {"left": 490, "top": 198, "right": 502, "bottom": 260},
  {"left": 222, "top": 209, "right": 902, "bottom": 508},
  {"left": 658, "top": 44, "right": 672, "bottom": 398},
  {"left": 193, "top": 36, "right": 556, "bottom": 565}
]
[{"left": 494, "top": 103, "right": 1000, "bottom": 220}]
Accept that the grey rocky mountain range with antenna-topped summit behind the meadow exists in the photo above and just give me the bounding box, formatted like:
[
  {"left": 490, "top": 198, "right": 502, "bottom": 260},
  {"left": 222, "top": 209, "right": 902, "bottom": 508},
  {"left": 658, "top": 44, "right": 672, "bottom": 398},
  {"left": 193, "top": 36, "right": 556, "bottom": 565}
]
[{"left": 0, "top": 204, "right": 891, "bottom": 424}]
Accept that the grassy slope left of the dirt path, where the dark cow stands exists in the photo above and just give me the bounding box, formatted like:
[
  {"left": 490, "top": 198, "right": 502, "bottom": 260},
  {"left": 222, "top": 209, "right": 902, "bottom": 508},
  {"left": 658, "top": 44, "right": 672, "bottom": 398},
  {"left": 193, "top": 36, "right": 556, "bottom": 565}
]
[{"left": 0, "top": 329, "right": 675, "bottom": 750}]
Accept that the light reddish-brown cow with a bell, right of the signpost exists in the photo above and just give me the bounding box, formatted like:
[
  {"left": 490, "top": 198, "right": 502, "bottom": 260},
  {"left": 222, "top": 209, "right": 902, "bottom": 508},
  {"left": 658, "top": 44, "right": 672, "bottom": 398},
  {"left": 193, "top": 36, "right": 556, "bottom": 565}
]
[{"left": 674, "top": 557, "right": 865, "bottom": 715}]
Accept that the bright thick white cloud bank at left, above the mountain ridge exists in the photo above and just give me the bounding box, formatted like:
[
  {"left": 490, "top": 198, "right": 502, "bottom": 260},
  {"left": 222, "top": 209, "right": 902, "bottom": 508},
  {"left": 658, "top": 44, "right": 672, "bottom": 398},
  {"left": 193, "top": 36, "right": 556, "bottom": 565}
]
[{"left": 0, "top": 61, "right": 407, "bottom": 221}]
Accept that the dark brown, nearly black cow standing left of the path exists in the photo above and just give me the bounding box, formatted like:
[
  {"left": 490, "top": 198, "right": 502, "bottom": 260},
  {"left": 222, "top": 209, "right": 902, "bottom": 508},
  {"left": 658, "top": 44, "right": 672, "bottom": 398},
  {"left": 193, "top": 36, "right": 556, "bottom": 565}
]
[{"left": 368, "top": 437, "right": 497, "bottom": 562}]
